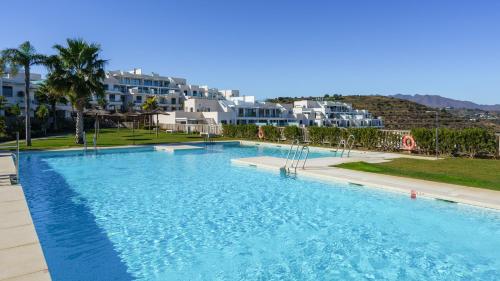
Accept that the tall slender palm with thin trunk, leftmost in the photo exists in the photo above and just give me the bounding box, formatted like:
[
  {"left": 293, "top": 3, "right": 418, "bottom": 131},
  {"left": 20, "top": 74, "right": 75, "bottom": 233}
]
[{"left": 1, "top": 41, "right": 46, "bottom": 146}]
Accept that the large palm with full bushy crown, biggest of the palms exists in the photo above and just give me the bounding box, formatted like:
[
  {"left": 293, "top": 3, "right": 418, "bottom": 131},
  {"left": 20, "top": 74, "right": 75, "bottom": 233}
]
[{"left": 48, "top": 39, "right": 106, "bottom": 144}]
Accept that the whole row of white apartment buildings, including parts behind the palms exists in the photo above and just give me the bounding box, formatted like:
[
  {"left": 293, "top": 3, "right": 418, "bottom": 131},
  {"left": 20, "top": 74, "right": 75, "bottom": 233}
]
[{"left": 0, "top": 68, "right": 383, "bottom": 127}]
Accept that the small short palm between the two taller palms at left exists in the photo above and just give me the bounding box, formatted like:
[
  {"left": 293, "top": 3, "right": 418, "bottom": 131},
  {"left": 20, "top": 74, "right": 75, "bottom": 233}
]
[{"left": 35, "top": 75, "right": 68, "bottom": 131}]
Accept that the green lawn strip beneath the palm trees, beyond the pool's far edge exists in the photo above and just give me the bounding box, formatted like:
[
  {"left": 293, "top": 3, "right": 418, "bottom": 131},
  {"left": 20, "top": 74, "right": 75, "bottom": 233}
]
[{"left": 0, "top": 129, "right": 222, "bottom": 150}]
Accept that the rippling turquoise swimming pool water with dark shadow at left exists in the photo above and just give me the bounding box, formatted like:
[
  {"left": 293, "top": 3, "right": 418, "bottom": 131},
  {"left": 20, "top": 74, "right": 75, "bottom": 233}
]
[{"left": 21, "top": 145, "right": 500, "bottom": 280}]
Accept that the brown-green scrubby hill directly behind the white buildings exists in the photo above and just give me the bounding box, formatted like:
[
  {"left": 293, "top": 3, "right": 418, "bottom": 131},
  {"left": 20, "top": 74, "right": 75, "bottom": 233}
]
[{"left": 267, "top": 95, "right": 498, "bottom": 130}]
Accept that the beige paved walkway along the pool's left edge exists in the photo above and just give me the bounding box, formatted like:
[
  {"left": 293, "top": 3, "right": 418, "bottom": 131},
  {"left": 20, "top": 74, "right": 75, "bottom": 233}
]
[{"left": 0, "top": 153, "right": 51, "bottom": 281}]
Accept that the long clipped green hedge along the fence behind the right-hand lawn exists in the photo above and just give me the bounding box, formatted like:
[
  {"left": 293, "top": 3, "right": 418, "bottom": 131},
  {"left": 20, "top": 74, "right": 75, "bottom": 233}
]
[{"left": 223, "top": 125, "right": 497, "bottom": 157}]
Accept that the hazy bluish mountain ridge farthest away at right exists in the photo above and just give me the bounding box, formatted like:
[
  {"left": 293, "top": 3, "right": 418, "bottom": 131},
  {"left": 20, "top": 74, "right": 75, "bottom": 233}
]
[{"left": 391, "top": 94, "right": 500, "bottom": 111}]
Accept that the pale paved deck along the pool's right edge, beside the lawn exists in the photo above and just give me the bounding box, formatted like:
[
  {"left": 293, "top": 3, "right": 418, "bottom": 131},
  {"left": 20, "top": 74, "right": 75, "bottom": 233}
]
[{"left": 232, "top": 154, "right": 500, "bottom": 210}]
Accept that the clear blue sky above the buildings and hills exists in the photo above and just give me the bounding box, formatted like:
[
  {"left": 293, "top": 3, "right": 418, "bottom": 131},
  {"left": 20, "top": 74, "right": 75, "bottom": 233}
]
[{"left": 0, "top": 0, "right": 500, "bottom": 103}]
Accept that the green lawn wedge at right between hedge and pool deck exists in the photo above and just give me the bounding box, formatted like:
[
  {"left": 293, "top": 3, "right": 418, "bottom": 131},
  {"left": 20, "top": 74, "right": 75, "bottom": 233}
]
[{"left": 336, "top": 158, "right": 500, "bottom": 191}]
